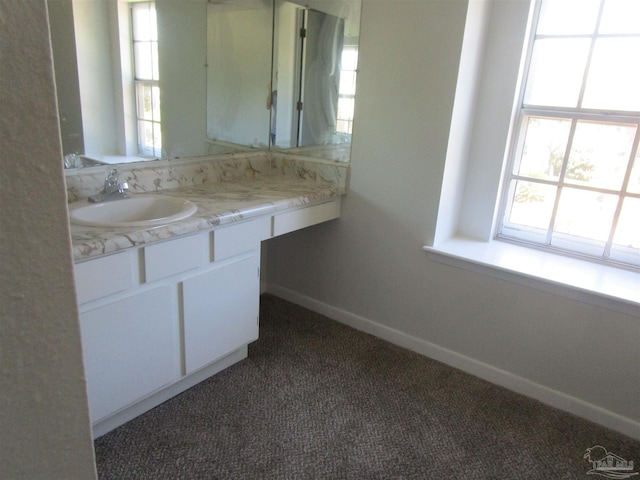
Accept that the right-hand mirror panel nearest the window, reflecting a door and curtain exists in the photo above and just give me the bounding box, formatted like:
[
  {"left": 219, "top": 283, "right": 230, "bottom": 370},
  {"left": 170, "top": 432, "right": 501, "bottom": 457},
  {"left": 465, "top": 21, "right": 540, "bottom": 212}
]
[{"left": 270, "top": 0, "right": 360, "bottom": 161}]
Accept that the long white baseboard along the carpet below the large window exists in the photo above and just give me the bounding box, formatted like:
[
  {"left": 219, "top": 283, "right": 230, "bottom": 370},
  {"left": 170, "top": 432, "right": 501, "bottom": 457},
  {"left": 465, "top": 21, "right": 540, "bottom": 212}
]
[{"left": 264, "top": 284, "right": 640, "bottom": 440}]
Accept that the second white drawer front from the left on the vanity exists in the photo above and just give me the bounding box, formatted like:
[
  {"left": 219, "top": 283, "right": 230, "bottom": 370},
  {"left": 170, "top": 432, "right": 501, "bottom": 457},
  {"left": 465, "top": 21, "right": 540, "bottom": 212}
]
[{"left": 144, "top": 233, "right": 210, "bottom": 282}]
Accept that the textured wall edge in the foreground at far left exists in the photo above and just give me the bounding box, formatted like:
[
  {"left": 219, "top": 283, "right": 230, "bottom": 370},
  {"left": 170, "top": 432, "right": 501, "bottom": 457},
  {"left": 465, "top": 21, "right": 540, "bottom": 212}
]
[{"left": 0, "top": 0, "right": 96, "bottom": 479}]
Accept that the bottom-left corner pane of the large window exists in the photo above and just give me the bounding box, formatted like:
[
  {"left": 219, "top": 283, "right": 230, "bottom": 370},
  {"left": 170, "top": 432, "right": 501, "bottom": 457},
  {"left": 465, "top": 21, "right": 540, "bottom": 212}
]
[{"left": 506, "top": 180, "right": 556, "bottom": 231}]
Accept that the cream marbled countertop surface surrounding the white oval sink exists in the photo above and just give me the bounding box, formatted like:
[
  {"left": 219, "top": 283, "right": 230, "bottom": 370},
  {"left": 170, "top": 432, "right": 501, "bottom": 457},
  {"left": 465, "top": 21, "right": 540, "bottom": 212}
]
[{"left": 71, "top": 175, "right": 345, "bottom": 262}]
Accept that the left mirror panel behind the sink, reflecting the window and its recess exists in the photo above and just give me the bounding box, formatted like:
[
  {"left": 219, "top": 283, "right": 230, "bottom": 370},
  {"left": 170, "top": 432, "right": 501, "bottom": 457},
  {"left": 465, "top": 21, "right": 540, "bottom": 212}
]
[{"left": 53, "top": 0, "right": 208, "bottom": 165}]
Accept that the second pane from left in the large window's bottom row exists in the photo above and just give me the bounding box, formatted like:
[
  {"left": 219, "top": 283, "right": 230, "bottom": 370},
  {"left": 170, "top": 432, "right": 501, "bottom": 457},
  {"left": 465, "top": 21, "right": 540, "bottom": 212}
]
[{"left": 553, "top": 188, "right": 618, "bottom": 242}]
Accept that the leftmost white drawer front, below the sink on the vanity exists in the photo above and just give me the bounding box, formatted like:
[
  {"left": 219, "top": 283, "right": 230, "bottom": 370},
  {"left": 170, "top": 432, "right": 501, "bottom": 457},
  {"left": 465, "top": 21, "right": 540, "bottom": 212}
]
[{"left": 75, "top": 252, "right": 137, "bottom": 304}]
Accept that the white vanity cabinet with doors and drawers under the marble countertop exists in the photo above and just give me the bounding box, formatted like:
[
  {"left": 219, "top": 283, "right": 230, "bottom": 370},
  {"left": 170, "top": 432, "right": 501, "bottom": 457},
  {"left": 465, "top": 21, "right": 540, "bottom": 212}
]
[{"left": 75, "top": 200, "right": 340, "bottom": 436}]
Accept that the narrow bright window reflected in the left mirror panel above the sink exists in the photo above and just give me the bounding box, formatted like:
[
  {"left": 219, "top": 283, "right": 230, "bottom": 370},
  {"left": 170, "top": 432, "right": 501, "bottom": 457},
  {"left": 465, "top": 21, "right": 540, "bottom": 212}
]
[{"left": 131, "top": 2, "right": 162, "bottom": 157}]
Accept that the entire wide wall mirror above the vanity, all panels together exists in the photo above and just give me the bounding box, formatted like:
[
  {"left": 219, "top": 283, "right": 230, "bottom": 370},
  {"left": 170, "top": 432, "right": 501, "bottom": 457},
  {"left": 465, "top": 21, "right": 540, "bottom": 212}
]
[{"left": 48, "top": 0, "right": 360, "bottom": 168}]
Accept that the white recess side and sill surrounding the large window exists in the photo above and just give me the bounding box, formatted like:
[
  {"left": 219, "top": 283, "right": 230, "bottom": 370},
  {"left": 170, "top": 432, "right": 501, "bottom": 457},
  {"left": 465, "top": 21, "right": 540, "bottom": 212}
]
[{"left": 424, "top": 0, "right": 640, "bottom": 315}]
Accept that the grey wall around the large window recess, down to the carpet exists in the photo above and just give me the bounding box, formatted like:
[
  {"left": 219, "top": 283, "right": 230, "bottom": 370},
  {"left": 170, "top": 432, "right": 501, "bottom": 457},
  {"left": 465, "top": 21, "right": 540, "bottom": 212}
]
[{"left": 265, "top": 0, "right": 640, "bottom": 437}]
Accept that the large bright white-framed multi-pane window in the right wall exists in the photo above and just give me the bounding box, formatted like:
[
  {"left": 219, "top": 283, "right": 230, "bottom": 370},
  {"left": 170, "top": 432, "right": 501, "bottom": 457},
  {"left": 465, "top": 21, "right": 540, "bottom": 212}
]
[{"left": 497, "top": 0, "right": 640, "bottom": 266}]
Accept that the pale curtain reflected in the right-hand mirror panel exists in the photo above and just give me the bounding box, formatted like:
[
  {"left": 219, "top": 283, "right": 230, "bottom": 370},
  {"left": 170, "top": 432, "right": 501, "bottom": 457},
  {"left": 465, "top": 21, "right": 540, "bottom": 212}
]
[{"left": 302, "top": 14, "right": 344, "bottom": 145}]
